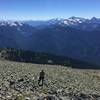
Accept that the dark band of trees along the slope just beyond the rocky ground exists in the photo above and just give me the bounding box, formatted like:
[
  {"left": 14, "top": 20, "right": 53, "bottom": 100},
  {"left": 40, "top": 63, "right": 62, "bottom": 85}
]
[{"left": 0, "top": 48, "right": 100, "bottom": 69}]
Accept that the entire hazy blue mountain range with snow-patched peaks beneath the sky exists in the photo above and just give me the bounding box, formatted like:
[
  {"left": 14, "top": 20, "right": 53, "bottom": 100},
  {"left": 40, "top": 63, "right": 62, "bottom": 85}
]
[{"left": 0, "top": 16, "right": 100, "bottom": 65}]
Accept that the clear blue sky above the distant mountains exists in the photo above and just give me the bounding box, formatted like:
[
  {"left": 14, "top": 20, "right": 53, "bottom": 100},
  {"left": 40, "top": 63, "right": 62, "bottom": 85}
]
[{"left": 0, "top": 0, "right": 100, "bottom": 20}]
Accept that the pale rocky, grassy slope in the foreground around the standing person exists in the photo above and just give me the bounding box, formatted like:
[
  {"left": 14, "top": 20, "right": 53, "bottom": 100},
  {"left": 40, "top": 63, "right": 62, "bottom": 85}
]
[{"left": 0, "top": 61, "right": 100, "bottom": 100}]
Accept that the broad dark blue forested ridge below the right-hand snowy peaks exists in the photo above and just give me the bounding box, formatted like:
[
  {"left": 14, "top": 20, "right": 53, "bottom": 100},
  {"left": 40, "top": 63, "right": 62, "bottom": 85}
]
[{"left": 30, "top": 25, "right": 100, "bottom": 65}]
